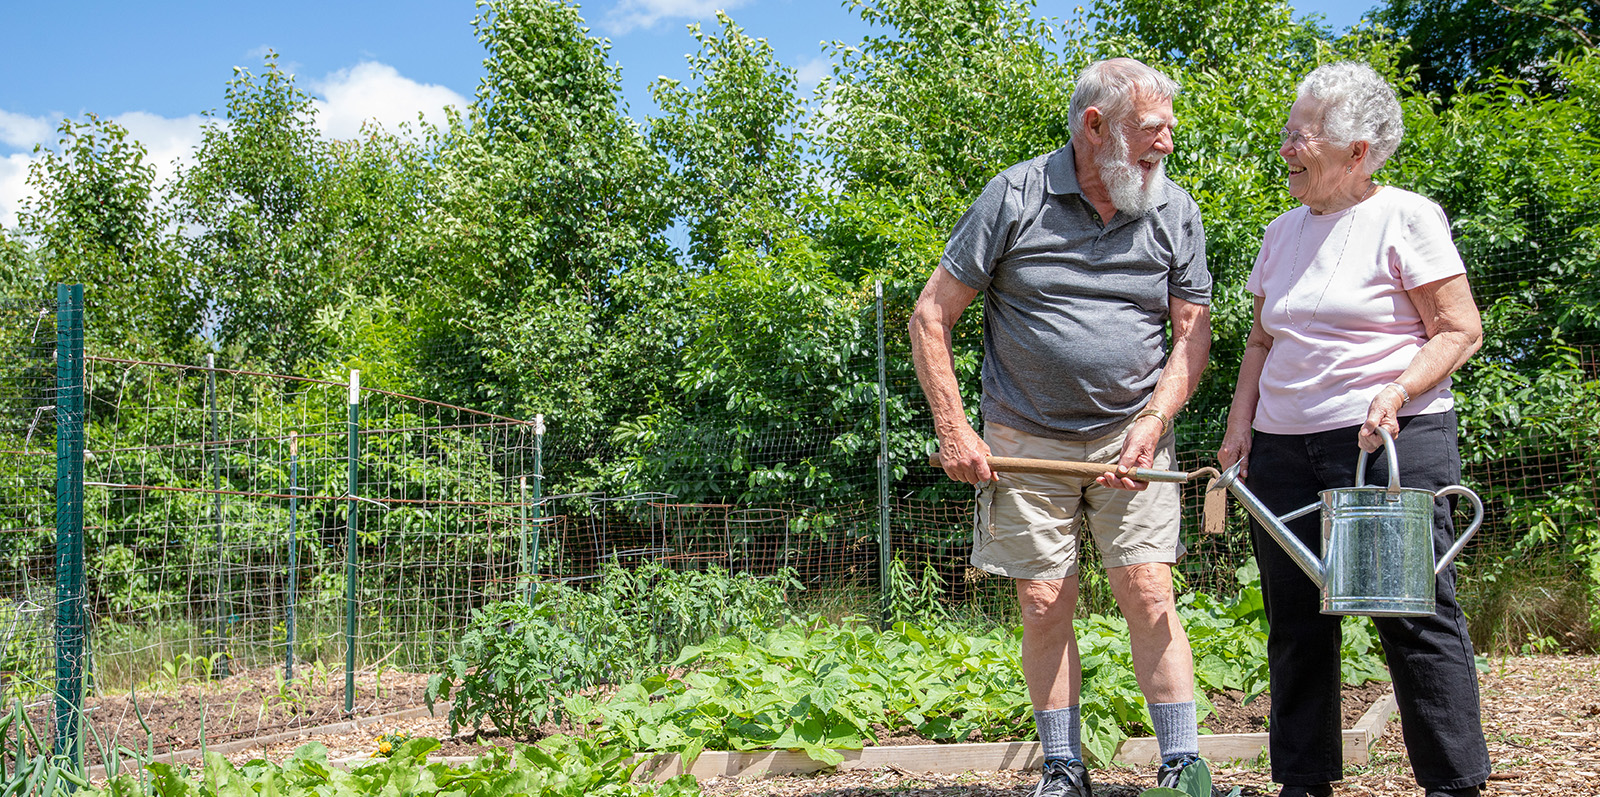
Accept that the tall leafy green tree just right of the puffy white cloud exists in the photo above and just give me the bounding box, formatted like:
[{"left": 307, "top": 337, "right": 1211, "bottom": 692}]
[{"left": 419, "top": 0, "right": 683, "bottom": 451}]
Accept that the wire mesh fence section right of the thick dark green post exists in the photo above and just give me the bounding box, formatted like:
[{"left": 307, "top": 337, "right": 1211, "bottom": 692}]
[{"left": 85, "top": 357, "right": 536, "bottom": 687}]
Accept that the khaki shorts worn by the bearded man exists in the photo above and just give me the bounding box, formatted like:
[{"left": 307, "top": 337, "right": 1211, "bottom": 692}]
[{"left": 973, "top": 424, "right": 1186, "bottom": 581}]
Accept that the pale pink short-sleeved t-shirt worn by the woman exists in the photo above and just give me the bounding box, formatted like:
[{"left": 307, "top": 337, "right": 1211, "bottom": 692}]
[{"left": 1245, "top": 187, "right": 1467, "bottom": 434}]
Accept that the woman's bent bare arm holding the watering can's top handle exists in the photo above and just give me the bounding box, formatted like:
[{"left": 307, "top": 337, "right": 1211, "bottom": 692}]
[{"left": 1358, "top": 274, "right": 1483, "bottom": 451}]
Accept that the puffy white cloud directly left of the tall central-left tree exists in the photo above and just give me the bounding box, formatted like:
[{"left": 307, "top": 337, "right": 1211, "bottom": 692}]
[{"left": 310, "top": 61, "right": 467, "bottom": 139}]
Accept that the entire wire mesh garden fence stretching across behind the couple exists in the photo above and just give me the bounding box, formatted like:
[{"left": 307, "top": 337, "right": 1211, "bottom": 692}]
[{"left": 0, "top": 204, "right": 1600, "bottom": 752}]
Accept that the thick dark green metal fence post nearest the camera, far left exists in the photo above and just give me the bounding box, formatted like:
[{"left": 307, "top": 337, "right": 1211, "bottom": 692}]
[{"left": 54, "top": 285, "right": 85, "bottom": 765}]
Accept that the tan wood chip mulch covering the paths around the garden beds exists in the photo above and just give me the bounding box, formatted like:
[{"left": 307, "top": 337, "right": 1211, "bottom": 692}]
[{"left": 216, "top": 655, "right": 1600, "bottom": 797}]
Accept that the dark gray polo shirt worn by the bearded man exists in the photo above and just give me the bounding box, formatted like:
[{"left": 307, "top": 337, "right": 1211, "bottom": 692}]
[{"left": 939, "top": 142, "right": 1211, "bottom": 440}]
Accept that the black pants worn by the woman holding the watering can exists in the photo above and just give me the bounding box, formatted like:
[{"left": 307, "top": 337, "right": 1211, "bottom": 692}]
[{"left": 1245, "top": 411, "right": 1490, "bottom": 789}]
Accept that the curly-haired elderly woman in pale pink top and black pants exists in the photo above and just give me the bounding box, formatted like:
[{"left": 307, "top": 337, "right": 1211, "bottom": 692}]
[{"left": 1218, "top": 62, "right": 1490, "bottom": 797}]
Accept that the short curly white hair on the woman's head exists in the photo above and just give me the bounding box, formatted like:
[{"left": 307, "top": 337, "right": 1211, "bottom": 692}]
[{"left": 1296, "top": 61, "right": 1405, "bottom": 174}]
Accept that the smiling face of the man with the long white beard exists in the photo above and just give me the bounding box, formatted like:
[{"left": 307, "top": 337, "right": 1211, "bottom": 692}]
[{"left": 1094, "top": 94, "right": 1176, "bottom": 214}]
